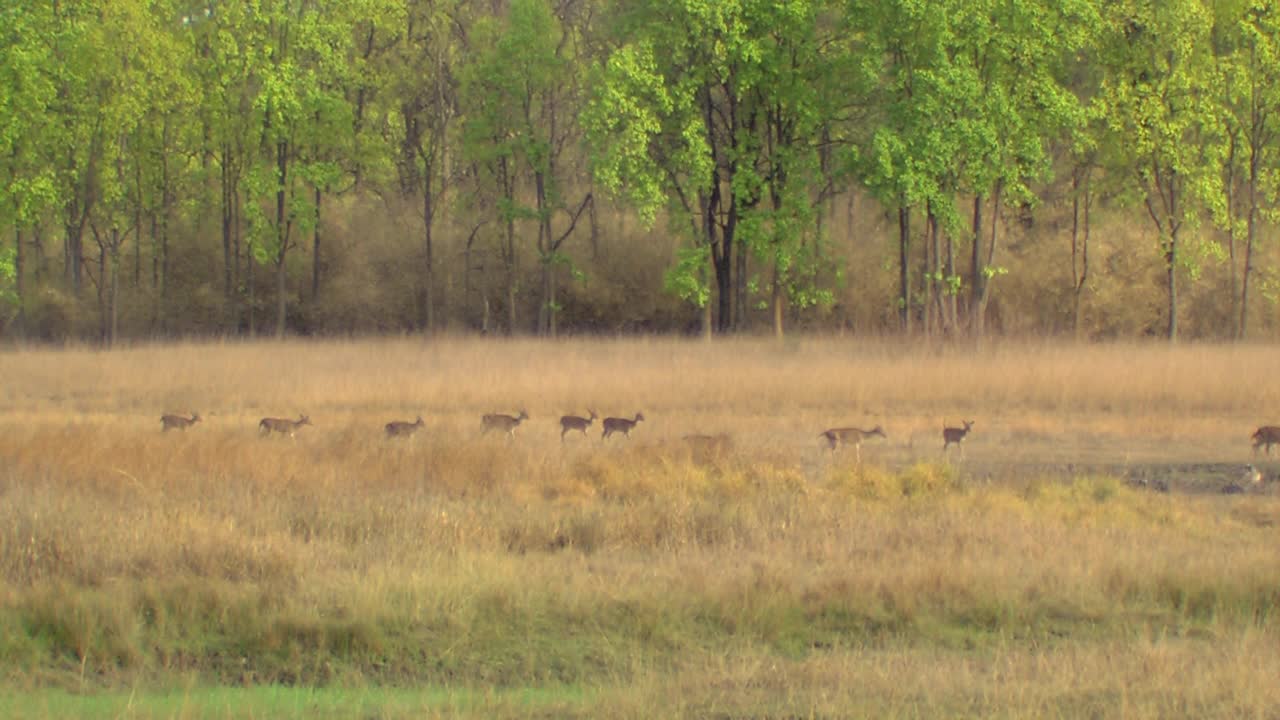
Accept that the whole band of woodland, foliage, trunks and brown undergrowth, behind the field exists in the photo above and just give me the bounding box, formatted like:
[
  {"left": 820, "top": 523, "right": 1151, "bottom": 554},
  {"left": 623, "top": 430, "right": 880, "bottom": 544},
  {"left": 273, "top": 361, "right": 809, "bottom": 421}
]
[{"left": 0, "top": 0, "right": 1280, "bottom": 343}]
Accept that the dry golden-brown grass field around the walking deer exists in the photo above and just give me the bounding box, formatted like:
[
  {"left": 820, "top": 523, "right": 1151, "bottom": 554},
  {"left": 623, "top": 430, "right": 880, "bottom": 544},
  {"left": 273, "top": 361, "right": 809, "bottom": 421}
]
[{"left": 0, "top": 340, "right": 1280, "bottom": 717}]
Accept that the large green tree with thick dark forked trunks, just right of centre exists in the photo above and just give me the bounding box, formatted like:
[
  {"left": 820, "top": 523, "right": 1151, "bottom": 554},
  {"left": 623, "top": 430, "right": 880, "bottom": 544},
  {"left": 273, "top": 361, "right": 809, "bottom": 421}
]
[{"left": 584, "top": 0, "right": 831, "bottom": 332}]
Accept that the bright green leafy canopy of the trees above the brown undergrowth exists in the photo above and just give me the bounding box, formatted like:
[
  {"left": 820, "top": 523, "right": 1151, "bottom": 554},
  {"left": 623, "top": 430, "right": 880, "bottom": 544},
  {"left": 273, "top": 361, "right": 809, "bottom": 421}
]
[{"left": 0, "top": 0, "right": 1280, "bottom": 335}]
